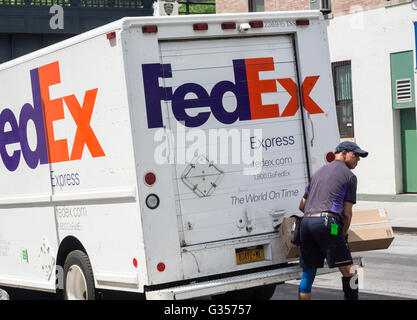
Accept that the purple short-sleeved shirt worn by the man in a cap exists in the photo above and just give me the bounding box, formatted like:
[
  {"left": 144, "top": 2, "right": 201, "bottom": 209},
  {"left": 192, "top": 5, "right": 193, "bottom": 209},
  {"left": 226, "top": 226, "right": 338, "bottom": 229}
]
[{"left": 304, "top": 160, "right": 357, "bottom": 215}]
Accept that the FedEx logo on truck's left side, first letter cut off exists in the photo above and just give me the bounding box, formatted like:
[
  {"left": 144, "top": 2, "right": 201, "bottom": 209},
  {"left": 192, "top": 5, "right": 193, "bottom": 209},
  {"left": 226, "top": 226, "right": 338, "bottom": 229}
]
[{"left": 0, "top": 61, "right": 105, "bottom": 171}]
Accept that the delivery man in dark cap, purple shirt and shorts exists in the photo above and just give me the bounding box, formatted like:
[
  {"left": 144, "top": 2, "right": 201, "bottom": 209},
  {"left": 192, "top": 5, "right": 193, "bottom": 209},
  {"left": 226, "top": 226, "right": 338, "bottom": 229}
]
[{"left": 299, "top": 141, "right": 368, "bottom": 300}]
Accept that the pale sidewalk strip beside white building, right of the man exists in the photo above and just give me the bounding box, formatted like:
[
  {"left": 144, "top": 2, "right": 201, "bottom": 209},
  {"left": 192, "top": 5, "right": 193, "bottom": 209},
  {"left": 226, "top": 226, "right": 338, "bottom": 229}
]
[{"left": 353, "top": 200, "right": 417, "bottom": 232}]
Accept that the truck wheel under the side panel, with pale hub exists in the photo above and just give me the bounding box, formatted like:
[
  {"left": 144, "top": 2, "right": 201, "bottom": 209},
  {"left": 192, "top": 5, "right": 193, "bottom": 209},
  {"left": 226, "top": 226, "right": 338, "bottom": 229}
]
[{"left": 64, "top": 250, "right": 96, "bottom": 300}]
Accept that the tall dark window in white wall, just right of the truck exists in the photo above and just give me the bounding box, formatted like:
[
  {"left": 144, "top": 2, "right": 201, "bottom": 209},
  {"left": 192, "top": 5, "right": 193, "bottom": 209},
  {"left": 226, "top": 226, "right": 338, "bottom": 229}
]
[{"left": 332, "top": 61, "right": 354, "bottom": 138}]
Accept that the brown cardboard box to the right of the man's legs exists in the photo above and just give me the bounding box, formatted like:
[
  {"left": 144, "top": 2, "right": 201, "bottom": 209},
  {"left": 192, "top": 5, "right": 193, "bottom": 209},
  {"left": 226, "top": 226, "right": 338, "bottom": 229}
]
[{"left": 348, "top": 209, "right": 394, "bottom": 252}]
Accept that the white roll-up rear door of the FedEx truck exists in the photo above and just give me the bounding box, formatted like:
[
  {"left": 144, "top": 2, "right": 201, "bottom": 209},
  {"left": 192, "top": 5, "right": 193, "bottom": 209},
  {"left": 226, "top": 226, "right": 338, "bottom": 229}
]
[{"left": 160, "top": 35, "right": 308, "bottom": 245}]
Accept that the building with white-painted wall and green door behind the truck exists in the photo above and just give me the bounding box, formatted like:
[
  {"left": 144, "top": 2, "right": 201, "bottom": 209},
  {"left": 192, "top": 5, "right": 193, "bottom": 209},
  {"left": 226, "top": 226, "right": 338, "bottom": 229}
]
[{"left": 216, "top": 0, "right": 417, "bottom": 199}]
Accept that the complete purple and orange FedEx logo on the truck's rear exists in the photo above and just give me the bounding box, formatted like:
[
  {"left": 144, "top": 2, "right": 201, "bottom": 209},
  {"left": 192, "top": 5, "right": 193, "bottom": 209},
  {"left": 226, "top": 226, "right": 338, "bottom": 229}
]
[{"left": 142, "top": 57, "right": 324, "bottom": 128}]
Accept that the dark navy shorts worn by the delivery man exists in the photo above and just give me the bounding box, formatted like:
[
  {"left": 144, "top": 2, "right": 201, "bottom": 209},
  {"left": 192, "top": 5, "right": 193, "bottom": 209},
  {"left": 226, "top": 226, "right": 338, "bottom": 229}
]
[{"left": 300, "top": 217, "right": 353, "bottom": 268}]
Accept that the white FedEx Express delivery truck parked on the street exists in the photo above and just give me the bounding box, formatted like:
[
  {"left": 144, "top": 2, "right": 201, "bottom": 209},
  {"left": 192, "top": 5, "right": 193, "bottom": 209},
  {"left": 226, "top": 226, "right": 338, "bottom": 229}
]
[{"left": 0, "top": 11, "right": 339, "bottom": 299}]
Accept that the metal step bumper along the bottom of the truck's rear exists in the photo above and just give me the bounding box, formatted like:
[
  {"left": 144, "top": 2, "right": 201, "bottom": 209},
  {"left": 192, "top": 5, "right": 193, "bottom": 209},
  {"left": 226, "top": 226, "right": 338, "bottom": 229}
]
[{"left": 146, "top": 257, "right": 363, "bottom": 300}]
